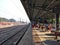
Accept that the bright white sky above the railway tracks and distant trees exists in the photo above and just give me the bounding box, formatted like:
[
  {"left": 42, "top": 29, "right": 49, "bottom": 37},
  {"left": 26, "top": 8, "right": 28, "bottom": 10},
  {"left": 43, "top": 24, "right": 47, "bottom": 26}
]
[{"left": 0, "top": 0, "right": 30, "bottom": 22}]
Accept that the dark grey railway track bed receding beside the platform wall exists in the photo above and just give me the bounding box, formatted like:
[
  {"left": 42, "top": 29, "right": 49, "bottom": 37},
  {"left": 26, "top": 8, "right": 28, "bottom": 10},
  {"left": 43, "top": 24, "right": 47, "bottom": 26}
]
[{"left": 0, "top": 25, "right": 29, "bottom": 45}]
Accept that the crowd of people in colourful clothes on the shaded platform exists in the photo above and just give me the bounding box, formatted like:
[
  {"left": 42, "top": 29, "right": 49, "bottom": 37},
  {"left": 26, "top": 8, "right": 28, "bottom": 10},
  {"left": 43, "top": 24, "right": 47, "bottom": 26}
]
[{"left": 32, "top": 20, "right": 52, "bottom": 31}]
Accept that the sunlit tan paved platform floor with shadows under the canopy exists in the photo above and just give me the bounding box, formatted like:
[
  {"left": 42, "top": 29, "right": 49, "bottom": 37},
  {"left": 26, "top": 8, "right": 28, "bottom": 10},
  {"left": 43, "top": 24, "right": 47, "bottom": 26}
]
[{"left": 32, "top": 29, "right": 60, "bottom": 45}]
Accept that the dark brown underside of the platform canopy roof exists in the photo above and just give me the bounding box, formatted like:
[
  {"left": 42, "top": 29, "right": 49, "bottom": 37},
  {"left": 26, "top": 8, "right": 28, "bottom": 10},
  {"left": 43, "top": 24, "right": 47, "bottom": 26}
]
[{"left": 21, "top": 0, "right": 60, "bottom": 20}]
